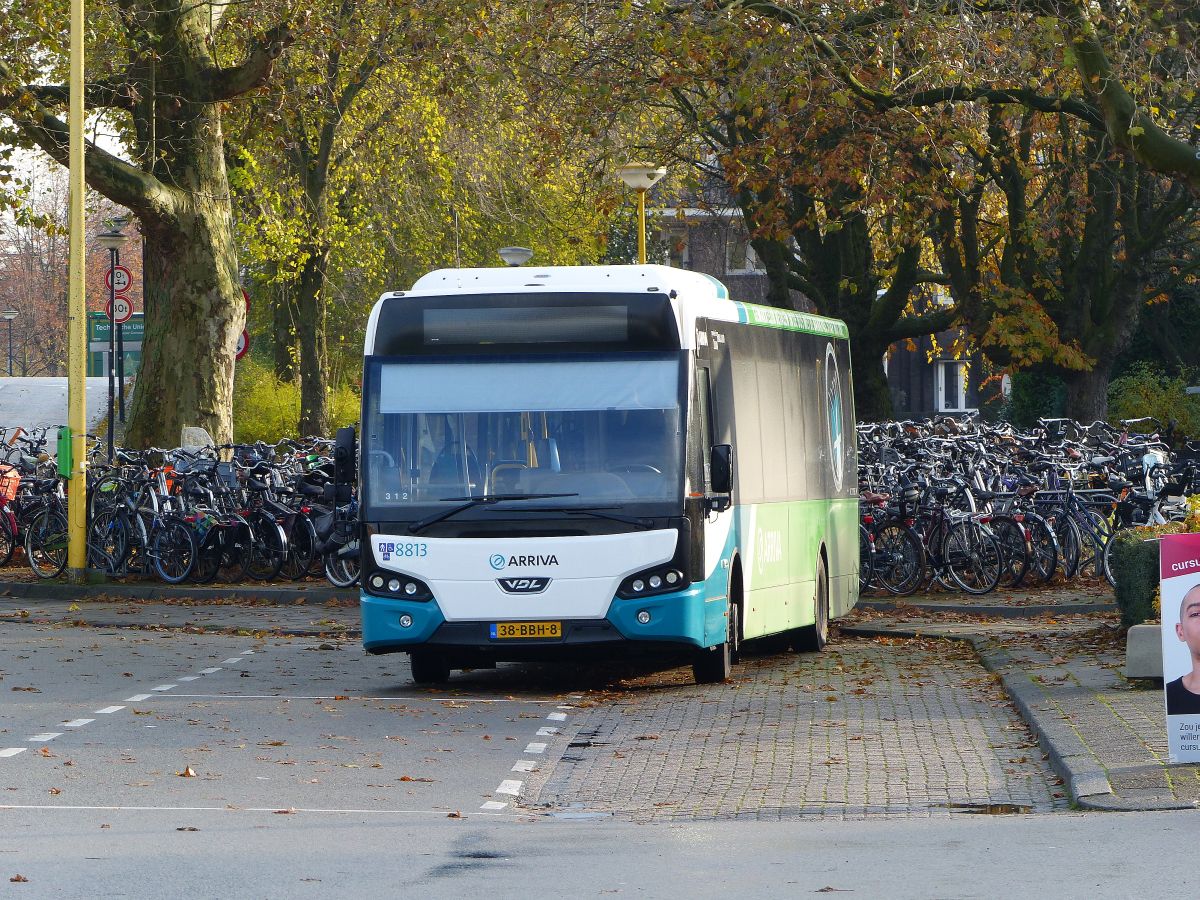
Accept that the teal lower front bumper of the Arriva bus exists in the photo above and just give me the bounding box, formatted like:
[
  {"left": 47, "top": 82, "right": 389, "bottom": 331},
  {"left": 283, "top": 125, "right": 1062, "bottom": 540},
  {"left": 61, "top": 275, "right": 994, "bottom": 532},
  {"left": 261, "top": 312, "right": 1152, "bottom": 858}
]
[{"left": 361, "top": 584, "right": 726, "bottom": 659}]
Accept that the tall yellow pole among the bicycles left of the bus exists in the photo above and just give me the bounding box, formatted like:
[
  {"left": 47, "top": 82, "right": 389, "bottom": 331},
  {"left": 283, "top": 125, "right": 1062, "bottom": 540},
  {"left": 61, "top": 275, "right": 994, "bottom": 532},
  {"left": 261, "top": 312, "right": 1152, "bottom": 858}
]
[{"left": 67, "top": 0, "right": 88, "bottom": 581}]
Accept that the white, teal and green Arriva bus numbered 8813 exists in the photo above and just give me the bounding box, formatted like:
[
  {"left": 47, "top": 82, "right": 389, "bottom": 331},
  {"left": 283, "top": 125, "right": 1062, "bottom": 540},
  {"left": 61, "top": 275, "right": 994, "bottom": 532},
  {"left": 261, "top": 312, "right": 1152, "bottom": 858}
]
[{"left": 358, "top": 265, "right": 859, "bottom": 684}]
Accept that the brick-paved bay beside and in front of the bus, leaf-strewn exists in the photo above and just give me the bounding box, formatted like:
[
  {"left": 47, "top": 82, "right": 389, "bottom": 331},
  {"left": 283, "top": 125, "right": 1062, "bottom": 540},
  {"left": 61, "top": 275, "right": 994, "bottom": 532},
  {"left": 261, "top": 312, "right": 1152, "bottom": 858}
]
[{"left": 526, "top": 637, "right": 1066, "bottom": 821}]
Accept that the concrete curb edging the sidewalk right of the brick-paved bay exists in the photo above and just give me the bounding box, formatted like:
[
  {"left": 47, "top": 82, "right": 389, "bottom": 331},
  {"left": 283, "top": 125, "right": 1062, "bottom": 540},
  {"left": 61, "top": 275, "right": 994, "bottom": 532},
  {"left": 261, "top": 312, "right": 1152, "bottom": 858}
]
[{"left": 842, "top": 625, "right": 1195, "bottom": 812}]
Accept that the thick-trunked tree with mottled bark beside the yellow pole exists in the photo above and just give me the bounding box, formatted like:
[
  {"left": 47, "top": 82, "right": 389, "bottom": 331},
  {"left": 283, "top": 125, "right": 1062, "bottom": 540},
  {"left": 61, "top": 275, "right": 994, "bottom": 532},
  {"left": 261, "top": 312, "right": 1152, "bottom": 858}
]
[{"left": 0, "top": 0, "right": 292, "bottom": 446}]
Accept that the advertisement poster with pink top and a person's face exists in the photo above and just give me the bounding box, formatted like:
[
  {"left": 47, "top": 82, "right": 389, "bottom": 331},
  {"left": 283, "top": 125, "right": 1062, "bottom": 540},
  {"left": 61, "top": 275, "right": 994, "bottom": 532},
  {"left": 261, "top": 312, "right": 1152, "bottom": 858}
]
[{"left": 1158, "top": 534, "right": 1200, "bottom": 762}]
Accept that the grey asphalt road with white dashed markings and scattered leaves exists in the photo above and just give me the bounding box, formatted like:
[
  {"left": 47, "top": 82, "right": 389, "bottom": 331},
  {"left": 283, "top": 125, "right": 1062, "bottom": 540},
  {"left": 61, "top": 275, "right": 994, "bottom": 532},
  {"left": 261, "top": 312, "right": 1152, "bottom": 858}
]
[{"left": 0, "top": 625, "right": 1196, "bottom": 898}]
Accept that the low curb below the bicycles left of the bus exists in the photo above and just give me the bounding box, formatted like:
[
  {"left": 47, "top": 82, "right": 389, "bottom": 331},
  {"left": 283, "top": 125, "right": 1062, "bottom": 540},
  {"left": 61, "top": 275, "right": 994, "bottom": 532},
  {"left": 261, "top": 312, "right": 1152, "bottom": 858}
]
[{"left": 0, "top": 581, "right": 359, "bottom": 604}]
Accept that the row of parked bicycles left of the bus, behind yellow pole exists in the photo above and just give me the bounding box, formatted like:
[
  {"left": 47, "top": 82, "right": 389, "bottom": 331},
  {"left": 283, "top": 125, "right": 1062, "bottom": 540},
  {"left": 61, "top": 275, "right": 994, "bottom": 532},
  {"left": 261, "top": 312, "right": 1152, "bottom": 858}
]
[{"left": 0, "top": 430, "right": 359, "bottom": 587}]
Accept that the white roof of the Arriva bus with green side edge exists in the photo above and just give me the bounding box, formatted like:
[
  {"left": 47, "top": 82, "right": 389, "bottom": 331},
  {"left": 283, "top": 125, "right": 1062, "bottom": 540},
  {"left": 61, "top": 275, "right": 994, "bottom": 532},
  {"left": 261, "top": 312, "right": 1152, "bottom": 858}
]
[{"left": 366, "top": 265, "right": 848, "bottom": 353}]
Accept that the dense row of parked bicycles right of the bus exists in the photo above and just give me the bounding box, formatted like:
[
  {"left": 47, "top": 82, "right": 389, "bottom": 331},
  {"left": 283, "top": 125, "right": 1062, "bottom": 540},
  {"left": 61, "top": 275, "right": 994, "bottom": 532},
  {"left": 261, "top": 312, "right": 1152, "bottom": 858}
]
[{"left": 858, "top": 416, "right": 1200, "bottom": 595}]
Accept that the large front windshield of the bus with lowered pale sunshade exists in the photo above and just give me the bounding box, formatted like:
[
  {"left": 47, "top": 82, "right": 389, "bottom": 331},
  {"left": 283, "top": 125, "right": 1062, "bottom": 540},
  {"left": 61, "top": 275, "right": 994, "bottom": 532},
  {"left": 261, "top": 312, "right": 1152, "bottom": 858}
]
[{"left": 362, "top": 353, "right": 684, "bottom": 517}]
